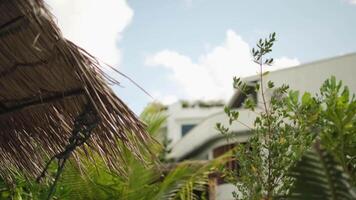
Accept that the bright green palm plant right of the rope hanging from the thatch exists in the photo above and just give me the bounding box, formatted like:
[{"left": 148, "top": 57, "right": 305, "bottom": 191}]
[{"left": 48, "top": 104, "right": 227, "bottom": 200}]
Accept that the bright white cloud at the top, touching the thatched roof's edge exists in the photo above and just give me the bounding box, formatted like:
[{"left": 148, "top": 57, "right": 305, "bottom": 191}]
[{"left": 46, "top": 0, "right": 133, "bottom": 65}]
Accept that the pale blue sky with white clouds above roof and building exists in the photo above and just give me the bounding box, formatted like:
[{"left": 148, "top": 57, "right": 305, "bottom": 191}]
[{"left": 47, "top": 0, "right": 356, "bottom": 113}]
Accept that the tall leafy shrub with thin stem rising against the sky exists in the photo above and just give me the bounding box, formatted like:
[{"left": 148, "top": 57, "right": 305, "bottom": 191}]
[{"left": 217, "top": 33, "right": 319, "bottom": 200}]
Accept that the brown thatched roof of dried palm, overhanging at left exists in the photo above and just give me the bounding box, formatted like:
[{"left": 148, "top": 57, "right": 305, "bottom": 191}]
[{"left": 0, "top": 0, "right": 150, "bottom": 176}]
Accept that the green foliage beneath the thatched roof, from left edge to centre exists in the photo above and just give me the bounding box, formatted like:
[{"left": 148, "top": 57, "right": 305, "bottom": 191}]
[{"left": 0, "top": 104, "right": 226, "bottom": 200}]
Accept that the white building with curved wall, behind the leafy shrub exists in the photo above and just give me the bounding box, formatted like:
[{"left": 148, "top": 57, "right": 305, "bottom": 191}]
[{"left": 164, "top": 53, "right": 356, "bottom": 200}]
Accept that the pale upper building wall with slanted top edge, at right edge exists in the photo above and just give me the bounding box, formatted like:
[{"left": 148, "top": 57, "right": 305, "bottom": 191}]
[{"left": 246, "top": 53, "right": 356, "bottom": 104}]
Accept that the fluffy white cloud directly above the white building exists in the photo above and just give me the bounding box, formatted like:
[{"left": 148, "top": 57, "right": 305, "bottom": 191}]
[{"left": 146, "top": 30, "right": 299, "bottom": 100}]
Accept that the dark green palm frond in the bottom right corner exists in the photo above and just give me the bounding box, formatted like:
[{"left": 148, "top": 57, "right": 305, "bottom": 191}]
[{"left": 287, "top": 143, "right": 356, "bottom": 200}]
